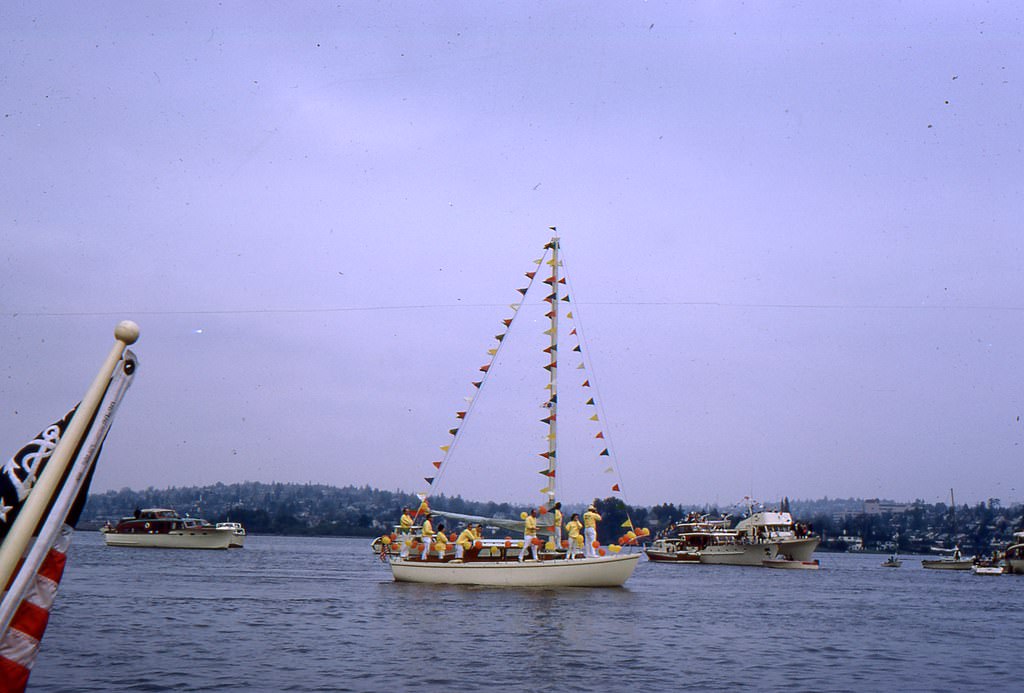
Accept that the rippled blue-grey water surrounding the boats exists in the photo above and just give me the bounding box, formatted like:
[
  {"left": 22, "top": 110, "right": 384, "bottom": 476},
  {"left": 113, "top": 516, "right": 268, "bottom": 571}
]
[{"left": 29, "top": 532, "right": 1024, "bottom": 693}]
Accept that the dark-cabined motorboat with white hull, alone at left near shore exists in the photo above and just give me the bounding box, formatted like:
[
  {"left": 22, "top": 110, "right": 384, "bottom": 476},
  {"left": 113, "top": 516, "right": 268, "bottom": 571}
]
[{"left": 99, "top": 508, "right": 234, "bottom": 549}]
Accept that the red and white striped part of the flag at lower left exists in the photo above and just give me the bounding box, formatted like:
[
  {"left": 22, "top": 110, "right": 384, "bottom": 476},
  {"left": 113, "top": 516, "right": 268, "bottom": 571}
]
[{"left": 0, "top": 525, "right": 74, "bottom": 693}]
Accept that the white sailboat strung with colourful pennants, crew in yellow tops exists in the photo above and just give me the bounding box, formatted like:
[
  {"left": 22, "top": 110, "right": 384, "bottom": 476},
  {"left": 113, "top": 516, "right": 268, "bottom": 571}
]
[{"left": 373, "top": 235, "right": 646, "bottom": 588}]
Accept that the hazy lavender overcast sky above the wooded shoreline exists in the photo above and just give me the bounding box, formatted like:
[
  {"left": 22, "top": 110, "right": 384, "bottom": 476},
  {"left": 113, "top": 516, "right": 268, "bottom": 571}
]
[{"left": 0, "top": 1, "right": 1024, "bottom": 505}]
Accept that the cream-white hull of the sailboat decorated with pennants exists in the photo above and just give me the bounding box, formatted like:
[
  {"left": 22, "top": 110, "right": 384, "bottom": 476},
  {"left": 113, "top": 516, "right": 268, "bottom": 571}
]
[{"left": 391, "top": 554, "right": 640, "bottom": 588}]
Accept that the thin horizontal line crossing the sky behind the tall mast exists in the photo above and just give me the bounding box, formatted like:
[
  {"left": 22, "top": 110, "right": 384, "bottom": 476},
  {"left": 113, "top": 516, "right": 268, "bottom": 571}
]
[{"left": 9, "top": 301, "right": 1024, "bottom": 317}]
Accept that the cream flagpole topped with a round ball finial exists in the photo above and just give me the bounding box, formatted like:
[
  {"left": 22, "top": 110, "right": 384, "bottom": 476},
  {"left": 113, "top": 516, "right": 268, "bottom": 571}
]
[{"left": 0, "top": 320, "right": 138, "bottom": 590}]
